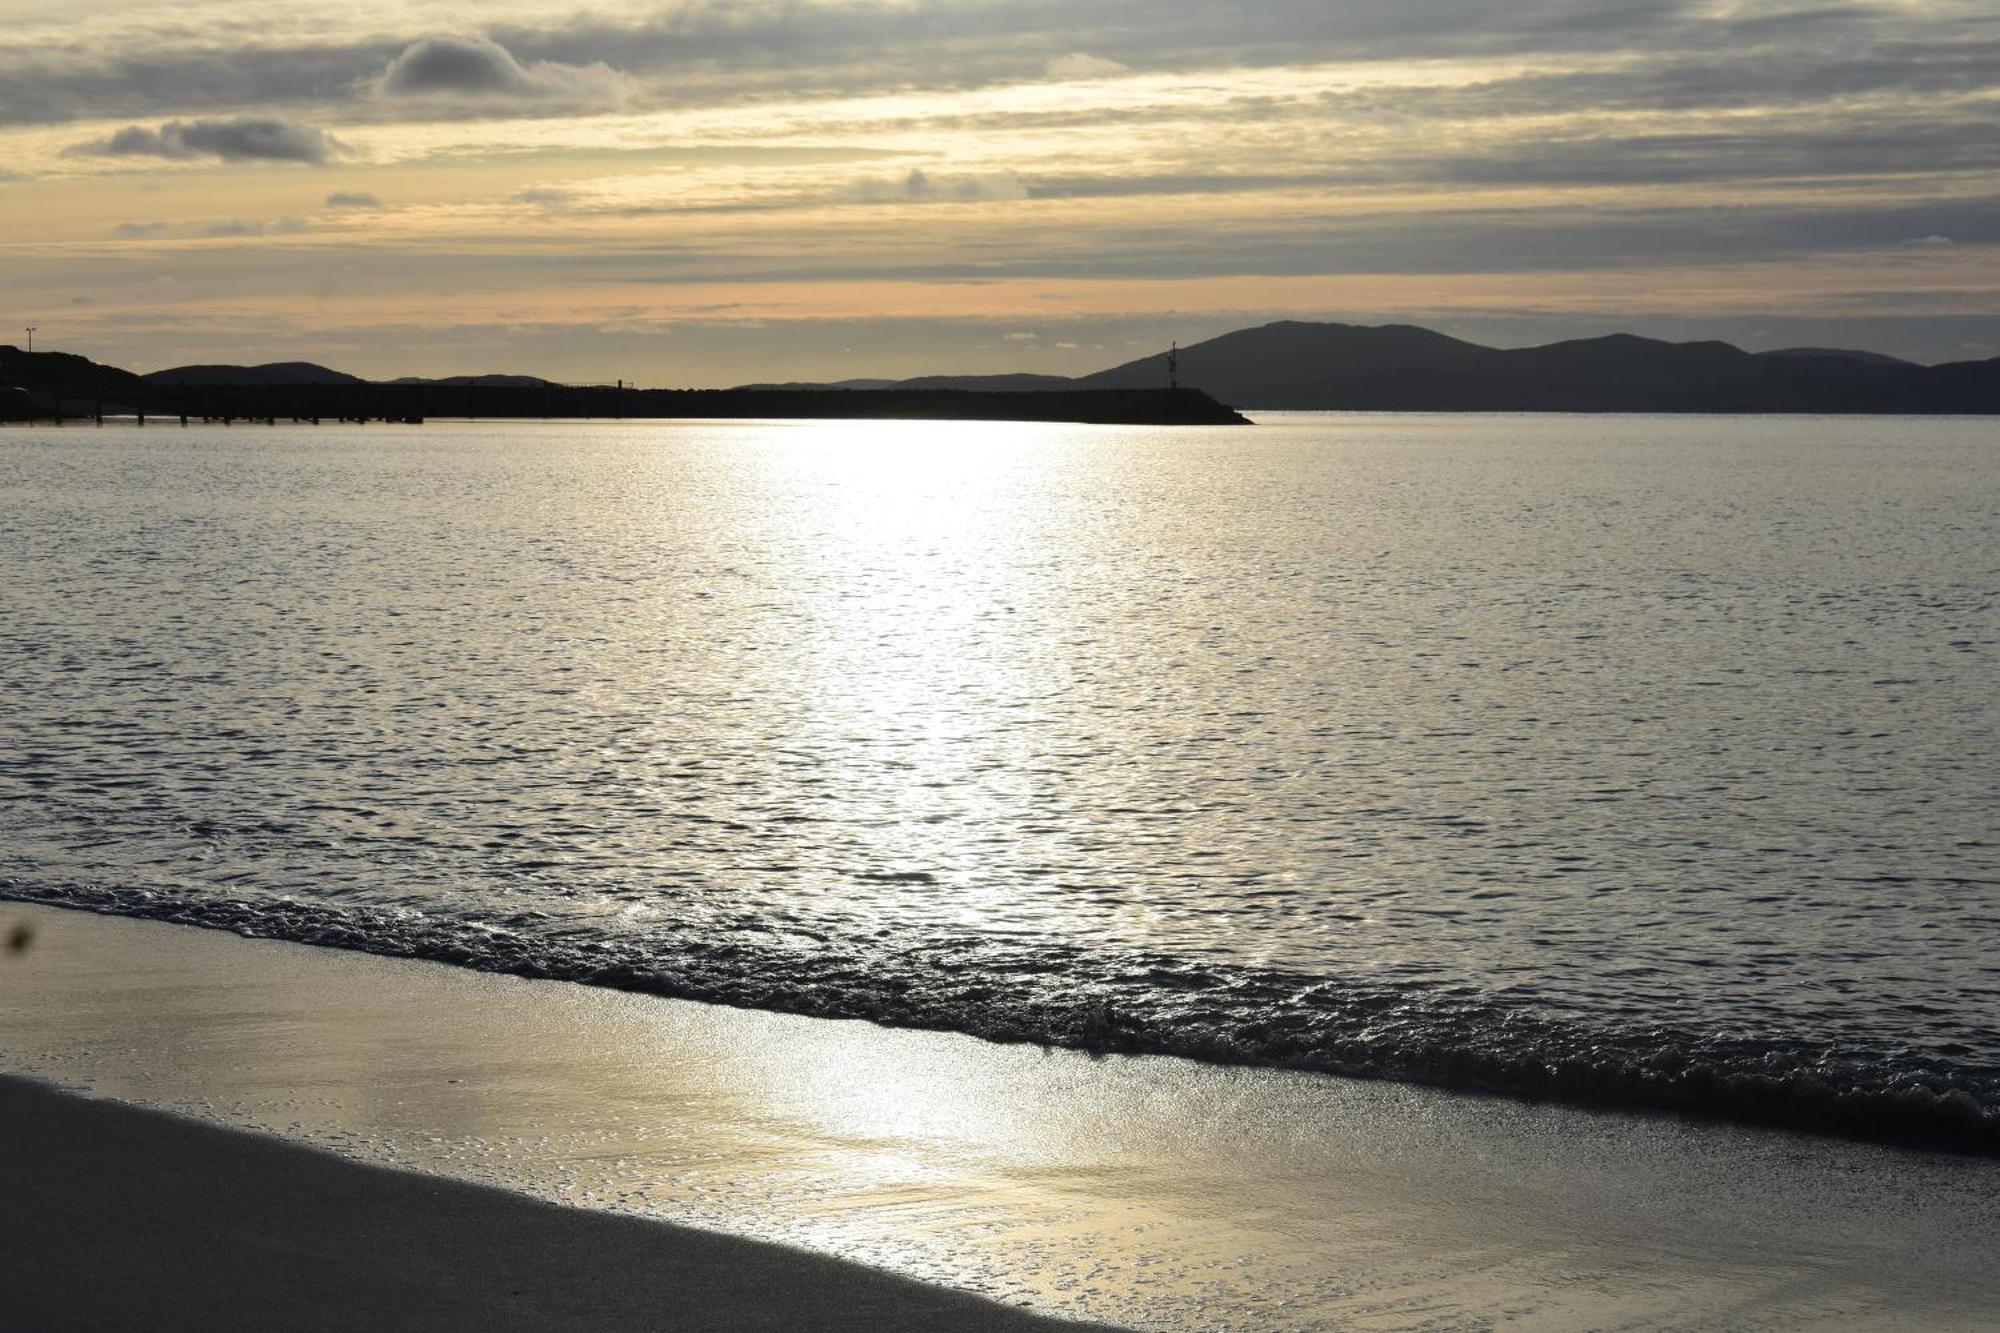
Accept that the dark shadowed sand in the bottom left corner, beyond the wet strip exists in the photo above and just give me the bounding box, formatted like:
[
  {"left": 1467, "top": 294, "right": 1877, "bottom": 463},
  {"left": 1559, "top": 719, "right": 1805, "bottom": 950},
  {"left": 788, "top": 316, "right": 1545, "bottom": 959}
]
[{"left": 0, "top": 1079, "right": 1092, "bottom": 1333}]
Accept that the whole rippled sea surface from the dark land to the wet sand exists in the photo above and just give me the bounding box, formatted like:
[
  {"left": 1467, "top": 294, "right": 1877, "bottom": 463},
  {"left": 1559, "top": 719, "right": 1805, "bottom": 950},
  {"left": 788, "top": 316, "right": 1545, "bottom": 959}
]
[{"left": 0, "top": 416, "right": 2000, "bottom": 1147}]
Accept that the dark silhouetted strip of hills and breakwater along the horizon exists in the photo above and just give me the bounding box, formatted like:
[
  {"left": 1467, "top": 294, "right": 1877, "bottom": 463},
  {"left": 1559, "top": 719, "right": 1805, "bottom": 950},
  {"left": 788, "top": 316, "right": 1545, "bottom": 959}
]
[{"left": 0, "top": 320, "right": 2000, "bottom": 424}]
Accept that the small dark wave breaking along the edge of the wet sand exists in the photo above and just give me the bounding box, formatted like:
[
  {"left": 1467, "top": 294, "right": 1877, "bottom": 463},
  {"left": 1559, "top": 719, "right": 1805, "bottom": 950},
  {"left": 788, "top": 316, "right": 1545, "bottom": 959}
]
[{"left": 0, "top": 881, "right": 2000, "bottom": 1155}]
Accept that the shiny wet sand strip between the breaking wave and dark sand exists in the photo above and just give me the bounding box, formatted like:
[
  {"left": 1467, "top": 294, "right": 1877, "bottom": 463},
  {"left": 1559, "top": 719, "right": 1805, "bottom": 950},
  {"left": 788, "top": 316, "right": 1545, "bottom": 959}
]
[{"left": 11, "top": 907, "right": 2000, "bottom": 1329}]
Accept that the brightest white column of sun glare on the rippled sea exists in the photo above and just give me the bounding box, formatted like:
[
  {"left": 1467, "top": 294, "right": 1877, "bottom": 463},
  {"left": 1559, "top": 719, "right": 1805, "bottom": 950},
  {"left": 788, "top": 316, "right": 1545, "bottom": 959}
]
[{"left": 716, "top": 422, "right": 1110, "bottom": 929}]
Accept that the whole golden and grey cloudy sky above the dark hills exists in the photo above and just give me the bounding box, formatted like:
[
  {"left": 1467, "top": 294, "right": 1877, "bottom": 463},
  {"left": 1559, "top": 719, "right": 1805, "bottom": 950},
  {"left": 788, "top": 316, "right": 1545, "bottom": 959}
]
[{"left": 0, "top": 0, "right": 2000, "bottom": 386}]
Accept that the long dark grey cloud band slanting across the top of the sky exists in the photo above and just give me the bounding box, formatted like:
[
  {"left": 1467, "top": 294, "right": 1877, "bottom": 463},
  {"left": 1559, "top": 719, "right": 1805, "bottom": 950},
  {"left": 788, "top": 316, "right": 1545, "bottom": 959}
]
[{"left": 0, "top": 0, "right": 1968, "bottom": 124}]
